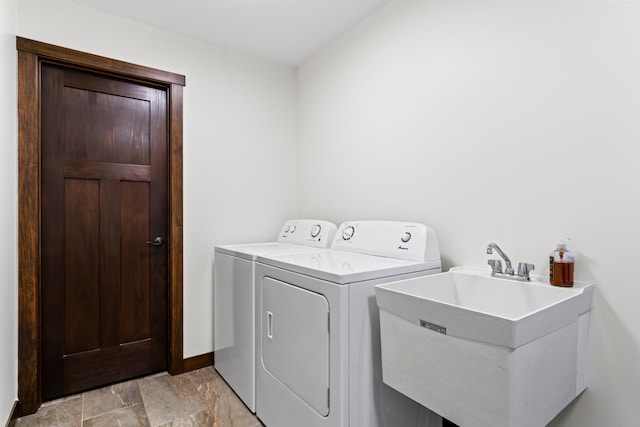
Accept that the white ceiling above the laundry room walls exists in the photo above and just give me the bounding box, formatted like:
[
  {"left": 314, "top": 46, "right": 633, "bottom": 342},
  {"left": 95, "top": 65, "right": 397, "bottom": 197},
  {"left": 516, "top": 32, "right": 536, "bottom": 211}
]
[{"left": 72, "top": 0, "right": 388, "bottom": 65}]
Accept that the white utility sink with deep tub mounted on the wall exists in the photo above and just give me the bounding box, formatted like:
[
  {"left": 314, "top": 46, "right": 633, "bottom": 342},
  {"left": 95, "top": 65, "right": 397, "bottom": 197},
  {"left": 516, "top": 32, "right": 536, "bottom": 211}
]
[{"left": 376, "top": 268, "right": 594, "bottom": 427}]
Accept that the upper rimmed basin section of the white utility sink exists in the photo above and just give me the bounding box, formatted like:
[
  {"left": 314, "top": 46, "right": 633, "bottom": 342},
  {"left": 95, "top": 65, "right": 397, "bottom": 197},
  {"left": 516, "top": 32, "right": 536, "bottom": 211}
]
[{"left": 376, "top": 269, "right": 593, "bottom": 348}]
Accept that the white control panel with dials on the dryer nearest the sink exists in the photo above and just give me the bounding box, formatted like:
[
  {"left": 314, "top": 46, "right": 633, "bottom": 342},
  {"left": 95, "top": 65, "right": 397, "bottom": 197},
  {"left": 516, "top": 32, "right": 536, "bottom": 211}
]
[{"left": 331, "top": 221, "right": 440, "bottom": 261}]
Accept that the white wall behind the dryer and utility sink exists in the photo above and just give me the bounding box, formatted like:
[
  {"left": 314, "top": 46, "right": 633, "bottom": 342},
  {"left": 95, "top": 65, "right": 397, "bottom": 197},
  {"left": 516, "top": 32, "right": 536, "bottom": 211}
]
[{"left": 298, "top": 0, "right": 640, "bottom": 427}]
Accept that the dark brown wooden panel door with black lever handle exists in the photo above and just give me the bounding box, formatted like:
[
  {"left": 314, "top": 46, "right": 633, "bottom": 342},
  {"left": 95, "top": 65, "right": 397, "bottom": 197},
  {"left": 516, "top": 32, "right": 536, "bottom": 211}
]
[{"left": 41, "top": 64, "right": 168, "bottom": 400}]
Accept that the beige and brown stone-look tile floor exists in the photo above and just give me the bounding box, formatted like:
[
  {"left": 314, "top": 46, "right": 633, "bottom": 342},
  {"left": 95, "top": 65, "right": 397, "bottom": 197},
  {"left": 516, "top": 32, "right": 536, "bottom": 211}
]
[{"left": 9, "top": 367, "right": 262, "bottom": 427}]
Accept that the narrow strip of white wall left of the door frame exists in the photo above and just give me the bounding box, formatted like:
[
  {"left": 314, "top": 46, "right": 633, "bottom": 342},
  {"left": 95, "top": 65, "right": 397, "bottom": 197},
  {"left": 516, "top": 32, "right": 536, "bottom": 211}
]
[{"left": 0, "top": 0, "right": 18, "bottom": 423}]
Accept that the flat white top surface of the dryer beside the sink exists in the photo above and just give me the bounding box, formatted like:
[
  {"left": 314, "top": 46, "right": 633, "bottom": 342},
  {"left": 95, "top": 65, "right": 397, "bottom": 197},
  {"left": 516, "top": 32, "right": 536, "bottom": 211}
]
[{"left": 257, "top": 250, "right": 441, "bottom": 285}]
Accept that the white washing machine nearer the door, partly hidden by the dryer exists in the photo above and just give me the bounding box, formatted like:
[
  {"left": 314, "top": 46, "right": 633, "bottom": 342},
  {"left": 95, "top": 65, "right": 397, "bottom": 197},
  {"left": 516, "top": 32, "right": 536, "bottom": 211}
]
[{"left": 213, "top": 219, "right": 336, "bottom": 412}]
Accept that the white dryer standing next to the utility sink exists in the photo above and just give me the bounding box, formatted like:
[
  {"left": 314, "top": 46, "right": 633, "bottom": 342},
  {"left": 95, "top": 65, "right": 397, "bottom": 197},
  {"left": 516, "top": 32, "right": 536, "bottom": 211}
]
[{"left": 255, "top": 221, "right": 442, "bottom": 427}]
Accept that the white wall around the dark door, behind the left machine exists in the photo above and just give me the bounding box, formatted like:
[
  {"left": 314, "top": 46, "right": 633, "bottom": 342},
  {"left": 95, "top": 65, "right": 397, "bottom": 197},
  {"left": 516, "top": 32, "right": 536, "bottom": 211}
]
[{"left": 16, "top": 0, "right": 297, "bottom": 358}]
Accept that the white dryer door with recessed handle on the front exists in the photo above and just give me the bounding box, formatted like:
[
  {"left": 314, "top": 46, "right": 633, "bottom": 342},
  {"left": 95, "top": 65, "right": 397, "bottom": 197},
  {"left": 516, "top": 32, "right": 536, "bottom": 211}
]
[{"left": 261, "top": 277, "right": 329, "bottom": 416}]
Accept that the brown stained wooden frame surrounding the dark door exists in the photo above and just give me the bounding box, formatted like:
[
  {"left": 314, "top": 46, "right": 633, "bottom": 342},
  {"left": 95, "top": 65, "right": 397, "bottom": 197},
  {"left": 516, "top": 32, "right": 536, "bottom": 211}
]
[{"left": 16, "top": 37, "right": 185, "bottom": 416}]
